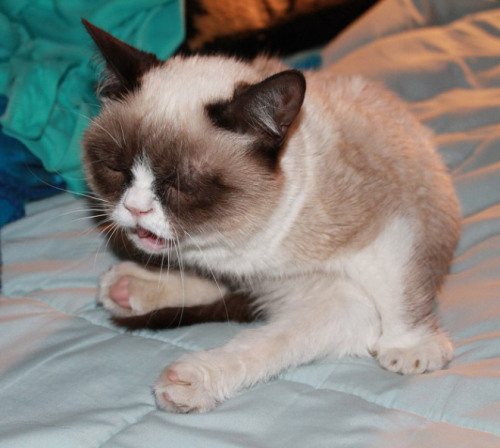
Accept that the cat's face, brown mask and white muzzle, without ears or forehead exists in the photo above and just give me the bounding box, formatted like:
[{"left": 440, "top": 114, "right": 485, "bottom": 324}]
[{"left": 84, "top": 96, "right": 280, "bottom": 253}]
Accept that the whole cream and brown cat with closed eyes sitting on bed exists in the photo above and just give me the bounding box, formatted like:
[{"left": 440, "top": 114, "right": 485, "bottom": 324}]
[{"left": 82, "top": 21, "right": 460, "bottom": 413}]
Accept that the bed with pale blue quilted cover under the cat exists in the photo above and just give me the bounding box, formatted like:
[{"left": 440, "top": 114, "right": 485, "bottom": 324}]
[{"left": 0, "top": 0, "right": 500, "bottom": 448}]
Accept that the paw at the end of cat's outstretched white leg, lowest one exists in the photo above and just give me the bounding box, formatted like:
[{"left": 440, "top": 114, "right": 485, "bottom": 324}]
[{"left": 154, "top": 354, "right": 227, "bottom": 414}]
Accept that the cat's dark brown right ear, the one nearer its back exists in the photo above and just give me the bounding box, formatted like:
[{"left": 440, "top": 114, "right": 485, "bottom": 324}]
[{"left": 207, "top": 70, "right": 306, "bottom": 160}]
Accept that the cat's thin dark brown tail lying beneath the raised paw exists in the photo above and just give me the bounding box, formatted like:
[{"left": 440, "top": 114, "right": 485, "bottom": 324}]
[{"left": 111, "top": 293, "right": 261, "bottom": 330}]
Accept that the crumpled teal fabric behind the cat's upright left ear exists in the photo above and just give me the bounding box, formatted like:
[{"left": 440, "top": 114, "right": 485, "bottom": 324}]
[{"left": 0, "top": 0, "right": 184, "bottom": 192}]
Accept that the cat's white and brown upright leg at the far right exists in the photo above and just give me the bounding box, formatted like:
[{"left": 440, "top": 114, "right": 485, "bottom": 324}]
[{"left": 346, "top": 218, "right": 453, "bottom": 374}]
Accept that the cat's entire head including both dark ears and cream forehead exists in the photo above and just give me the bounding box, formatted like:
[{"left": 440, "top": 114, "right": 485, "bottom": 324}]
[{"left": 82, "top": 22, "right": 305, "bottom": 253}]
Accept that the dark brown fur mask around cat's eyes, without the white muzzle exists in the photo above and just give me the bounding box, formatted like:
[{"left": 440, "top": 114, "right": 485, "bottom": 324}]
[{"left": 84, "top": 95, "right": 280, "bottom": 242}]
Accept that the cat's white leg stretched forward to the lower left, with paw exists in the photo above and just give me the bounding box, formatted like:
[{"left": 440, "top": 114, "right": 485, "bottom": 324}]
[{"left": 155, "top": 278, "right": 380, "bottom": 413}]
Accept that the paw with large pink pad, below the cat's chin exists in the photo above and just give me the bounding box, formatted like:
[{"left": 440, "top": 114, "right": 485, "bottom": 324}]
[{"left": 97, "top": 262, "right": 155, "bottom": 317}]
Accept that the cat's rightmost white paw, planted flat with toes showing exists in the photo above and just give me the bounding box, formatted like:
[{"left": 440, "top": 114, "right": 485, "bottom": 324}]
[{"left": 374, "top": 333, "right": 453, "bottom": 374}]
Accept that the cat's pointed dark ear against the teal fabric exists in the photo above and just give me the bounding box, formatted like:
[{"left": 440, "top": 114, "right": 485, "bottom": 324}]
[{"left": 82, "top": 18, "right": 162, "bottom": 98}]
